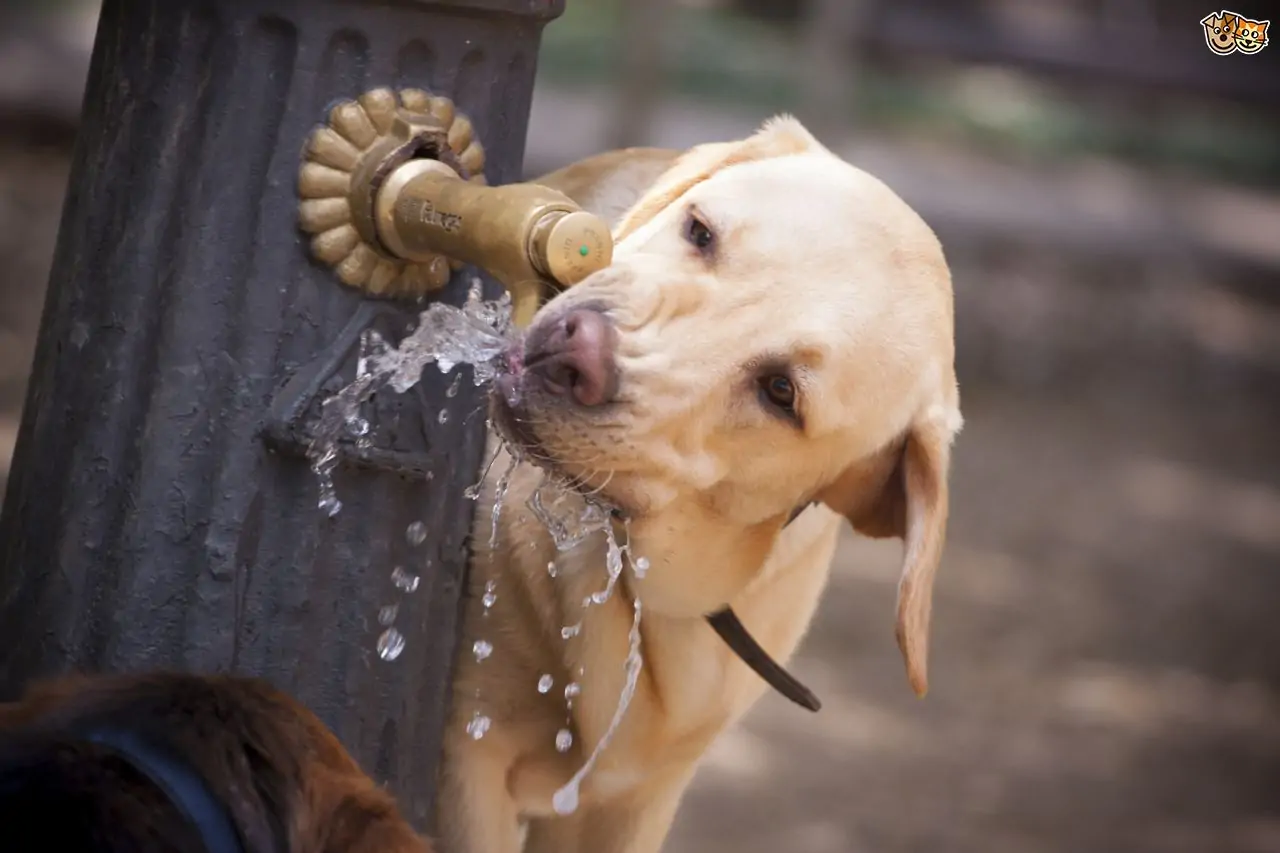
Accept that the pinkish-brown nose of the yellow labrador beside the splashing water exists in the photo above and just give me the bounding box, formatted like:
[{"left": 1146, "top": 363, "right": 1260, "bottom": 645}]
[{"left": 525, "top": 309, "right": 618, "bottom": 406}]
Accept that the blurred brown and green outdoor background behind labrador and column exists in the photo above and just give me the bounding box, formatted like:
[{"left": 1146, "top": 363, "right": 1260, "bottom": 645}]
[{"left": 0, "top": 0, "right": 1280, "bottom": 853}]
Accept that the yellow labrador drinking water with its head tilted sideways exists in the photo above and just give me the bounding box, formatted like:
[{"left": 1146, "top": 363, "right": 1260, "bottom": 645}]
[{"left": 439, "top": 118, "right": 961, "bottom": 853}]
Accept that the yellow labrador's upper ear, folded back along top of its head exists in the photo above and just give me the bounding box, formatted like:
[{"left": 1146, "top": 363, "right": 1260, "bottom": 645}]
[{"left": 613, "top": 115, "right": 826, "bottom": 242}]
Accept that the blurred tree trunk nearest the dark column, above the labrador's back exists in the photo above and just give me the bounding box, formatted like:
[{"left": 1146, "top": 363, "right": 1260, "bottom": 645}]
[{"left": 605, "top": 0, "right": 676, "bottom": 149}]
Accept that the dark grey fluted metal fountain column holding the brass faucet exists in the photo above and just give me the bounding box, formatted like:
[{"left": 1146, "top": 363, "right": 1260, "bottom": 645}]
[{"left": 0, "top": 0, "right": 563, "bottom": 827}]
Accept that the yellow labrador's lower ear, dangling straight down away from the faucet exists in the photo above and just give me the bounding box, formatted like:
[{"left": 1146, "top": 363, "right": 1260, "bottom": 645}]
[{"left": 819, "top": 412, "right": 959, "bottom": 697}]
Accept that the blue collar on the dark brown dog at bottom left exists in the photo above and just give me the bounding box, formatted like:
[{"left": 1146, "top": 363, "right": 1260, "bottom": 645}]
[{"left": 83, "top": 726, "right": 244, "bottom": 853}]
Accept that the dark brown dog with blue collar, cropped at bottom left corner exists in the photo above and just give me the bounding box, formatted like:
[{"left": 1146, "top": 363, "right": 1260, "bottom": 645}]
[{"left": 0, "top": 674, "right": 431, "bottom": 853}]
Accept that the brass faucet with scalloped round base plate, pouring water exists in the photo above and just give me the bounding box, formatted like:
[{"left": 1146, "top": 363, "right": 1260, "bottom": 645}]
[{"left": 298, "top": 88, "right": 613, "bottom": 325}]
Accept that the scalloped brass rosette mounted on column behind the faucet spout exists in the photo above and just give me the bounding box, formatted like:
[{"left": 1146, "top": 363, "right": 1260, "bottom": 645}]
[{"left": 298, "top": 88, "right": 485, "bottom": 298}]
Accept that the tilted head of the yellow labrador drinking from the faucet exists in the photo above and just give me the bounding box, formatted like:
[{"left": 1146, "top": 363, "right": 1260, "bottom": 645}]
[{"left": 495, "top": 118, "right": 960, "bottom": 693}]
